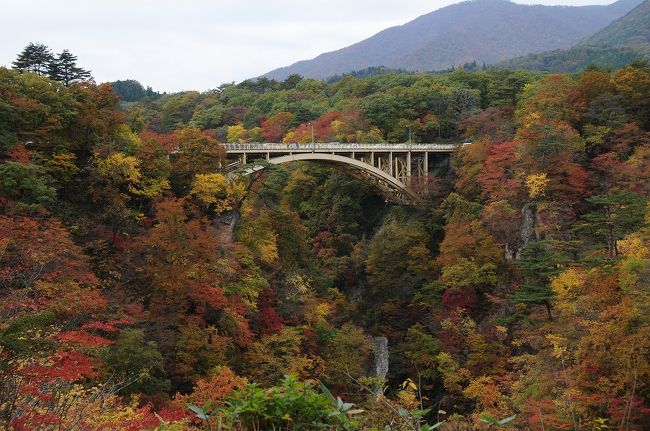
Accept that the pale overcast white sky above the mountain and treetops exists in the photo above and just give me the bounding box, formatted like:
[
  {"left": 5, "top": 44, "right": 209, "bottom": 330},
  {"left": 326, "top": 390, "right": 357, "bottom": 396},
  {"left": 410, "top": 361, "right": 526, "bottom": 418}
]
[{"left": 0, "top": 0, "right": 612, "bottom": 92}]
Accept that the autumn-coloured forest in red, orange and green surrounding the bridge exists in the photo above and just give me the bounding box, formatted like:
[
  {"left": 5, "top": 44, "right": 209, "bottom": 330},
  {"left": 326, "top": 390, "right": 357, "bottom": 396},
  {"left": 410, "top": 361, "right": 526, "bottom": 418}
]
[{"left": 0, "top": 51, "right": 650, "bottom": 431}]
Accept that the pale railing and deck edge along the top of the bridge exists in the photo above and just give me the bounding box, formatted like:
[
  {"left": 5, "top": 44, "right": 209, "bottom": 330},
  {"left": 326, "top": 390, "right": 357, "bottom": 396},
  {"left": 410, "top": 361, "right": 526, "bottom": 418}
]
[{"left": 223, "top": 142, "right": 469, "bottom": 152}]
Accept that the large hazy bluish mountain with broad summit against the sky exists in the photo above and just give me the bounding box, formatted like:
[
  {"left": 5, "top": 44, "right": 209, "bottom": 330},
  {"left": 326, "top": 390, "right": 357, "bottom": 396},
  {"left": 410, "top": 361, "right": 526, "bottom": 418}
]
[{"left": 264, "top": 0, "right": 642, "bottom": 80}]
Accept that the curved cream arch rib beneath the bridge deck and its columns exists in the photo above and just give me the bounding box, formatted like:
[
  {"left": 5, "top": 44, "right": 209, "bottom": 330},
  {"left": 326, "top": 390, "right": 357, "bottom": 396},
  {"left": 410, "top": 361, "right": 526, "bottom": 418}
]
[{"left": 239, "top": 152, "right": 417, "bottom": 205}]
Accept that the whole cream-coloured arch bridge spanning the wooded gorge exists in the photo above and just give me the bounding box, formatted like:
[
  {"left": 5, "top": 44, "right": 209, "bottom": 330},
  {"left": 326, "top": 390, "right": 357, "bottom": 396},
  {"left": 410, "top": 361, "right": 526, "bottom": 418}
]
[{"left": 224, "top": 142, "right": 460, "bottom": 205}]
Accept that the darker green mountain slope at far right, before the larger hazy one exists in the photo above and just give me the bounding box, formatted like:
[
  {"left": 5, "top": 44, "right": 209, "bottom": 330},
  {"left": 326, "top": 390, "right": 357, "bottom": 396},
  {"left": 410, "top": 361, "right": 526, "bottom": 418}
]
[{"left": 498, "top": 0, "right": 650, "bottom": 72}]
